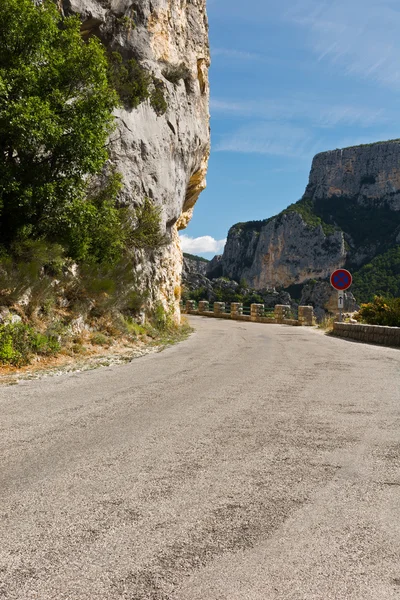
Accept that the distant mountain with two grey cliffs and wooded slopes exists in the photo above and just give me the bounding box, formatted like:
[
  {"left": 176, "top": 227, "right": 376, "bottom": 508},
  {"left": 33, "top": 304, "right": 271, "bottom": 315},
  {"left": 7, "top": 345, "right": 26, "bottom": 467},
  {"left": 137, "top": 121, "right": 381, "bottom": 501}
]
[{"left": 220, "top": 140, "right": 400, "bottom": 298}]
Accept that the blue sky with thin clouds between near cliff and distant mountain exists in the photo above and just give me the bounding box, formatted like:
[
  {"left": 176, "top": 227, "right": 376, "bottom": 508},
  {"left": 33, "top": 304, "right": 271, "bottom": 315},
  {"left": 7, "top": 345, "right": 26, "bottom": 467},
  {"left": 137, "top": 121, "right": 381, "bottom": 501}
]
[{"left": 181, "top": 0, "right": 400, "bottom": 258}]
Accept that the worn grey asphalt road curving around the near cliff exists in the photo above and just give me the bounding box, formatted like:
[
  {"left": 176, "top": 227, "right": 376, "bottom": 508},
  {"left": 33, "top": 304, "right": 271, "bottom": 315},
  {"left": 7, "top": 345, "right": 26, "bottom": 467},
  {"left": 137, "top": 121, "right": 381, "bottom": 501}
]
[{"left": 0, "top": 317, "right": 400, "bottom": 600}]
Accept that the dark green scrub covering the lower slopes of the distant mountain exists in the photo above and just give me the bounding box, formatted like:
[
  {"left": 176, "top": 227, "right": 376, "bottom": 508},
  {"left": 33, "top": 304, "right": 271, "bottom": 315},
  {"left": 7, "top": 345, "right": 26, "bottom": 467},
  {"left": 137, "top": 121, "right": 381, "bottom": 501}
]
[{"left": 222, "top": 174, "right": 400, "bottom": 302}]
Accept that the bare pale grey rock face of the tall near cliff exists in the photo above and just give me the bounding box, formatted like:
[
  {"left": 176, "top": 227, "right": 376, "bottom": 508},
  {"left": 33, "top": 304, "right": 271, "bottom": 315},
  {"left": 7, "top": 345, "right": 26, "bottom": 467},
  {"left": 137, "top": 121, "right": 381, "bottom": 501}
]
[{"left": 62, "top": 0, "right": 210, "bottom": 315}]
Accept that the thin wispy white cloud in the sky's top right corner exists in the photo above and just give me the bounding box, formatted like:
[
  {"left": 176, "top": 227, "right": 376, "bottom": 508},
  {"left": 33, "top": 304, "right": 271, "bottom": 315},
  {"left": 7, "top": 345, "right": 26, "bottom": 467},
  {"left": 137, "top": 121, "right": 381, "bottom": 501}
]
[{"left": 286, "top": 0, "right": 400, "bottom": 89}]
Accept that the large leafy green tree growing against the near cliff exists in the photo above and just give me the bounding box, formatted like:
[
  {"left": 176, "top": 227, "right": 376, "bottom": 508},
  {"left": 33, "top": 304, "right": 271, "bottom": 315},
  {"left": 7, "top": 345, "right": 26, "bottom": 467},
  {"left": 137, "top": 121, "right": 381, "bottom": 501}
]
[{"left": 0, "top": 0, "right": 118, "bottom": 251}]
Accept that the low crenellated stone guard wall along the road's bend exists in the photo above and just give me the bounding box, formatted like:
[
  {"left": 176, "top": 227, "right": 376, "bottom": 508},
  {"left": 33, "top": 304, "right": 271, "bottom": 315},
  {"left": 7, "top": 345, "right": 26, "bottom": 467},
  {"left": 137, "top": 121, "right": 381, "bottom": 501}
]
[{"left": 184, "top": 300, "right": 314, "bottom": 326}]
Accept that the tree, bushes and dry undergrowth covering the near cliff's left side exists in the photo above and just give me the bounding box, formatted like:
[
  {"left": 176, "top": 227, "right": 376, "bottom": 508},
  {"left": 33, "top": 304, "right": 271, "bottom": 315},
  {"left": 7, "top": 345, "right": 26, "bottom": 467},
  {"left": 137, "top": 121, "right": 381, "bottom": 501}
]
[{"left": 0, "top": 0, "right": 187, "bottom": 365}]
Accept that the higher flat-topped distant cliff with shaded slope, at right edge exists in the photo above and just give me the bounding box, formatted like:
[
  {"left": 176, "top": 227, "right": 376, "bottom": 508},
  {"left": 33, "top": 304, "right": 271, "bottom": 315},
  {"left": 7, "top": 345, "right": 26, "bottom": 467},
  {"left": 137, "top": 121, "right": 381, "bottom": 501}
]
[{"left": 304, "top": 140, "right": 400, "bottom": 269}]
